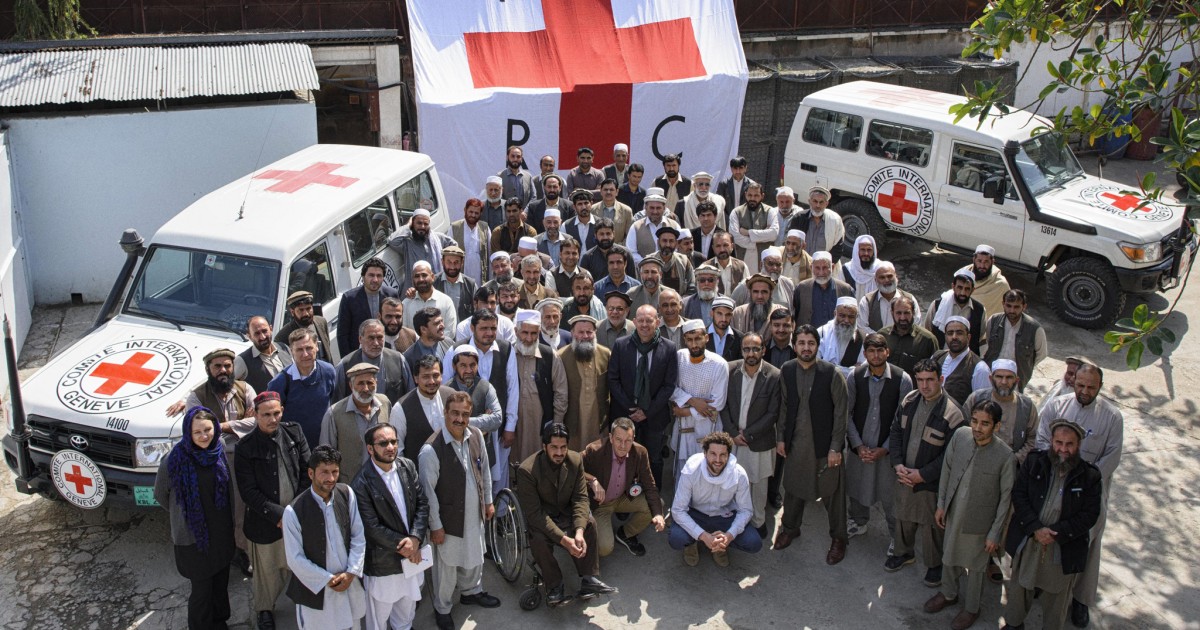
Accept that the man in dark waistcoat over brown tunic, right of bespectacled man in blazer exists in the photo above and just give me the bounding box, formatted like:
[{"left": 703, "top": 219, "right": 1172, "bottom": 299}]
[{"left": 774, "top": 324, "right": 847, "bottom": 564}]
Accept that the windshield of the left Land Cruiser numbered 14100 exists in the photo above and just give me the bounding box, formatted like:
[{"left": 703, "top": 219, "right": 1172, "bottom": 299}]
[{"left": 122, "top": 245, "right": 281, "bottom": 334}]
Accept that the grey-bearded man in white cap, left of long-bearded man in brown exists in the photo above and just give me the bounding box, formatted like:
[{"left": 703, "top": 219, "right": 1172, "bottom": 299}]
[{"left": 511, "top": 310, "right": 566, "bottom": 461}]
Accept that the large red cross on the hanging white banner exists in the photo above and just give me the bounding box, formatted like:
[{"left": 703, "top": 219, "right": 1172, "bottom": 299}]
[{"left": 463, "top": 0, "right": 707, "bottom": 168}]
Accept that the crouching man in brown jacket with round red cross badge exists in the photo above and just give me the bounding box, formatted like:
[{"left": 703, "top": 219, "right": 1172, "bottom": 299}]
[{"left": 583, "top": 418, "right": 666, "bottom": 557}]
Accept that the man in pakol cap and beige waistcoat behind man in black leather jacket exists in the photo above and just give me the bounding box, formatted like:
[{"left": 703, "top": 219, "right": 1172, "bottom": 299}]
[{"left": 320, "top": 364, "right": 391, "bottom": 484}]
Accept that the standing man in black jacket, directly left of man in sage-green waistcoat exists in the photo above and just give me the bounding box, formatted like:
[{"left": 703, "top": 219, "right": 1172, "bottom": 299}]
[{"left": 883, "top": 359, "right": 962, "bottom": 587}]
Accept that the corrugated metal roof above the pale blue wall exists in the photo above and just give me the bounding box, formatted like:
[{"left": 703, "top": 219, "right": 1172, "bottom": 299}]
[{"left": 0, "top": 43, "right": 319, "bottom": 107}]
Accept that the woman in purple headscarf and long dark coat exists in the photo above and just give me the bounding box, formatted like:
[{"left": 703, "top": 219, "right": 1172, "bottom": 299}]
[{"left": 154, "top": 407, "right": 235, "bottom": 630}]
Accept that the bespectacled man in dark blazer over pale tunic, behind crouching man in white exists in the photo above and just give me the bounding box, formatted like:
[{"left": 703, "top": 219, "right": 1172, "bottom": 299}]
[{"left": 721, "top": 332, "right": 782, "bottom": 536}]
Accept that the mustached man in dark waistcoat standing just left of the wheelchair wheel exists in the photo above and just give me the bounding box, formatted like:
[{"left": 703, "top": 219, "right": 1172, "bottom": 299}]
[{"left": 419, "top": 391, "right": 500, "bottom": 630}]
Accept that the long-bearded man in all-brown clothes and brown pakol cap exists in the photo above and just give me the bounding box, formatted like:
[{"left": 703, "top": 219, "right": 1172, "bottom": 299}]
[{"left": 558, "top": 314, "right": 612, "bottom": 451}]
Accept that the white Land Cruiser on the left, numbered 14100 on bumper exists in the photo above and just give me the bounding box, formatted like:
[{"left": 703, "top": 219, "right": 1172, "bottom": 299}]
[{"left": 4, "top": 145, "right": 449, "bottom": 509}]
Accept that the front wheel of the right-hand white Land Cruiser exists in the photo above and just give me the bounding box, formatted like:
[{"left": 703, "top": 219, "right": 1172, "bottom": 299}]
[{"left": 1046, "top": 256, "right": 1126, "bottom": 329}]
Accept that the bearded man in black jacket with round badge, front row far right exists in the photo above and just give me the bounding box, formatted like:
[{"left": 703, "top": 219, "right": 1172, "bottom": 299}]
[{"left": 1004, "top": 420, "right": 1103, "bottom": 629}]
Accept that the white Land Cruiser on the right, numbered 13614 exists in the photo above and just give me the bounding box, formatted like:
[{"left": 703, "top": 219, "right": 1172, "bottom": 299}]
[{"left": 784, "top": 82, "right": 1196, "bottom": 328}]
